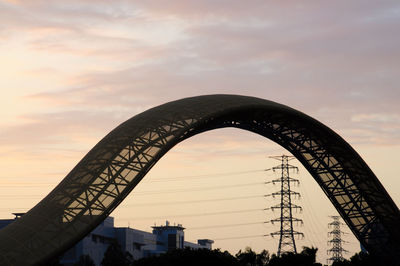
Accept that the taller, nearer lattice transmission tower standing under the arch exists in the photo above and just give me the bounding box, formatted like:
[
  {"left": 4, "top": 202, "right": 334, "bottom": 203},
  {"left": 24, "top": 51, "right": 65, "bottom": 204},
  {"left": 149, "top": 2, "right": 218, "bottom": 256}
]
[{"left": 267, "top": 155, "right": 304, "bottom": 257}]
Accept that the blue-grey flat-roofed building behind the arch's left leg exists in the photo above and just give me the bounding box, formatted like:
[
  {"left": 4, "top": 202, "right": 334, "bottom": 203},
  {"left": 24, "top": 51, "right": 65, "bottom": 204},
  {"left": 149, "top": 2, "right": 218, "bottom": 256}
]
[{"left": 0, "top": 213, "right": 214, "bottom": 266}]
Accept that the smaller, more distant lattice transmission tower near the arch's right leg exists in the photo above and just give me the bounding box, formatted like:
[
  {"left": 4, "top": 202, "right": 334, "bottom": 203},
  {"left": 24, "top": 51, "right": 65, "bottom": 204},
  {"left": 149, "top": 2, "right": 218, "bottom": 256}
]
[{"left": 327, "top": 216, "right": 348, "bottom": 263}]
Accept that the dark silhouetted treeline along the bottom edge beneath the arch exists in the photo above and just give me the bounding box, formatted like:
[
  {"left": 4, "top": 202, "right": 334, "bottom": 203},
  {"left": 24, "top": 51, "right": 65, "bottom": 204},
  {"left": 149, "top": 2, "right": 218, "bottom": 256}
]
[{"left": 52, "top": 243, "right": 379, "bottom": 266}]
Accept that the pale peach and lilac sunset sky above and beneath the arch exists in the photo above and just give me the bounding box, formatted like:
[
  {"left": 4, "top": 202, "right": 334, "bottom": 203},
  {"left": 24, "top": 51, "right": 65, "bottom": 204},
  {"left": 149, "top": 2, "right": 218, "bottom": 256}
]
[{"left": 0, "top": 0, "right": 400, "bottom": 262}]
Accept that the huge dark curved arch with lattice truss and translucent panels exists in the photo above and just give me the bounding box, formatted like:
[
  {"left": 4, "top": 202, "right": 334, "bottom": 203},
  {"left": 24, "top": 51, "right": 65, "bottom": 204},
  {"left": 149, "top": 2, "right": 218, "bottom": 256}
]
[{"left": 0, "top": 95, "right": 400, "bottom": 265}]
